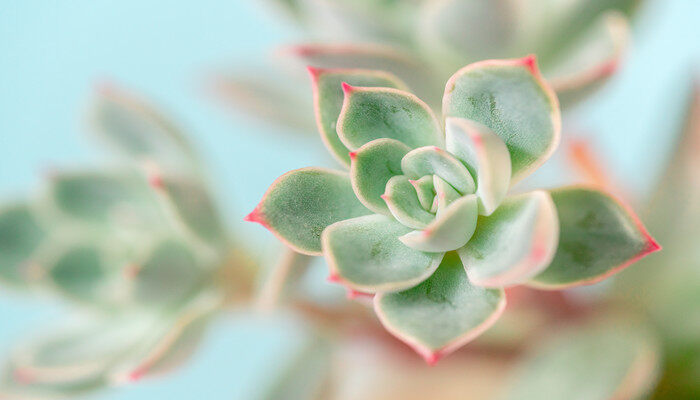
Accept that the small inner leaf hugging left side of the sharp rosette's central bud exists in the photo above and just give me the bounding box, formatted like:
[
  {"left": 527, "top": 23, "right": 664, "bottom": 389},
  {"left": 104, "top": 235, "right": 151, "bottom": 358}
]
[{"left": 382, "top": 175, "right": 435, "bottom": 229}]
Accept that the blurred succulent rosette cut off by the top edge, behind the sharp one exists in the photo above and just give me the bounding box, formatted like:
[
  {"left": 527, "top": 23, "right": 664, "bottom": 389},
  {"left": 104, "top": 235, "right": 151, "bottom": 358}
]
[{"left": 215, "top": 0, "right": 638, "bottom": 131}]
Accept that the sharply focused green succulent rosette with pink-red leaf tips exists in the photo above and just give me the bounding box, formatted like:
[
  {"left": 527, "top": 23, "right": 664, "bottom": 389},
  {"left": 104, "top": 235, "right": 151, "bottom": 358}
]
[{"left": 246, "top": 56, "right": 660, "bottom": 363}]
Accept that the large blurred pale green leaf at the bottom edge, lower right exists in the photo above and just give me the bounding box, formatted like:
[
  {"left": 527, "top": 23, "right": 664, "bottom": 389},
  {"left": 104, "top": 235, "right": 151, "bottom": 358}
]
[{"left": 499, "top": 318, "right": 659, "bottom": 400}]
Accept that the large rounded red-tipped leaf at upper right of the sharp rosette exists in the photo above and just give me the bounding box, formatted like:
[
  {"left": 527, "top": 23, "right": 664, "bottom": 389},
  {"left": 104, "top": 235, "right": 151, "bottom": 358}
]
[{"left": 442, "top": 56, "right": 561, "bottom": 184}]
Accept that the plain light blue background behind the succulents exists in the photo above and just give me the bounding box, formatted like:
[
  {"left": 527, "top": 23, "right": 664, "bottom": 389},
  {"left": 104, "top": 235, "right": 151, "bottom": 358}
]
[{"left": 0, "top": 0, "right": 700, "bottom": 399}]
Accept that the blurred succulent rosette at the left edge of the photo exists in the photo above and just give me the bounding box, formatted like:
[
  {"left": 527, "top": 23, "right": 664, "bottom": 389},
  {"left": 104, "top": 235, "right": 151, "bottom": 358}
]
[{"left": 0, "top": 88, "right": 252, "bottom": 399}]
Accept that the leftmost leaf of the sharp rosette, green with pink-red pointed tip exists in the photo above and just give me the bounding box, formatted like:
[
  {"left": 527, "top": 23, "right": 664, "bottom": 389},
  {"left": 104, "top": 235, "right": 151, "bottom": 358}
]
[{"left": 246, "top": 168, "right": 370, "bottom": 255}]
